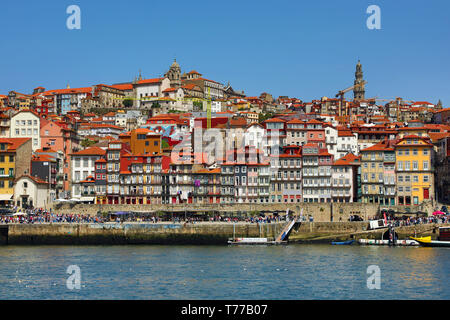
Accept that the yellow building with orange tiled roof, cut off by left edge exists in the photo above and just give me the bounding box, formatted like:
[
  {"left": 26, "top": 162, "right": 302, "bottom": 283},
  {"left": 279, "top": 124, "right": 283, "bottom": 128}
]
[{"left": 0, "top": 138, "right": 31, "bottom": 207}]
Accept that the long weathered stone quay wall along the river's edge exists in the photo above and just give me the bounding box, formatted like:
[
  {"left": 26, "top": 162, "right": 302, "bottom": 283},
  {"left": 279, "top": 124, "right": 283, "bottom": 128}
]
[{"left": 0, "top": 221, "right": 450, "bottom": 245}]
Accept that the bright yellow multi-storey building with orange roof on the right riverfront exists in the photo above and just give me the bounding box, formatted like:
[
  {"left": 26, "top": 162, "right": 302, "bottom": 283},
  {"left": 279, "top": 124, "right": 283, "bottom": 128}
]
[{"left": 395, "top": 135, "right": 434, "bottom": 205}]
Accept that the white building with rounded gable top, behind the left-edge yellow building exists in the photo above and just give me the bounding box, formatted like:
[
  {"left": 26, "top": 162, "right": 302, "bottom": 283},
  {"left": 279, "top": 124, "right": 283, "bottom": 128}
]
[{"left": 9, "top": 110, "right": 41, "bottom": 151}]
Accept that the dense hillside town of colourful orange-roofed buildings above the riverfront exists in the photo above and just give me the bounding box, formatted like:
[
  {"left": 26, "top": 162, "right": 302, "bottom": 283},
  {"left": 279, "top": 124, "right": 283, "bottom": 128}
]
[{"left": 0, "top": 60, "right": 450, "bottom": 209}]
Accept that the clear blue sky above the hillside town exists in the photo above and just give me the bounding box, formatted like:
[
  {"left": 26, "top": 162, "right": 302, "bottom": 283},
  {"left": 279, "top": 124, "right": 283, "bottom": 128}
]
[{"left": 0, "top": 0, "right": 450, "bottom": 106}]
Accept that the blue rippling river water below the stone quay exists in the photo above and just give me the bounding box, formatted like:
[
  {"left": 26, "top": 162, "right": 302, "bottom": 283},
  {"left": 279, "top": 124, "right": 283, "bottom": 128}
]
[{"left": 0, "top": 245, "right": 450, "bottom": 300}]
